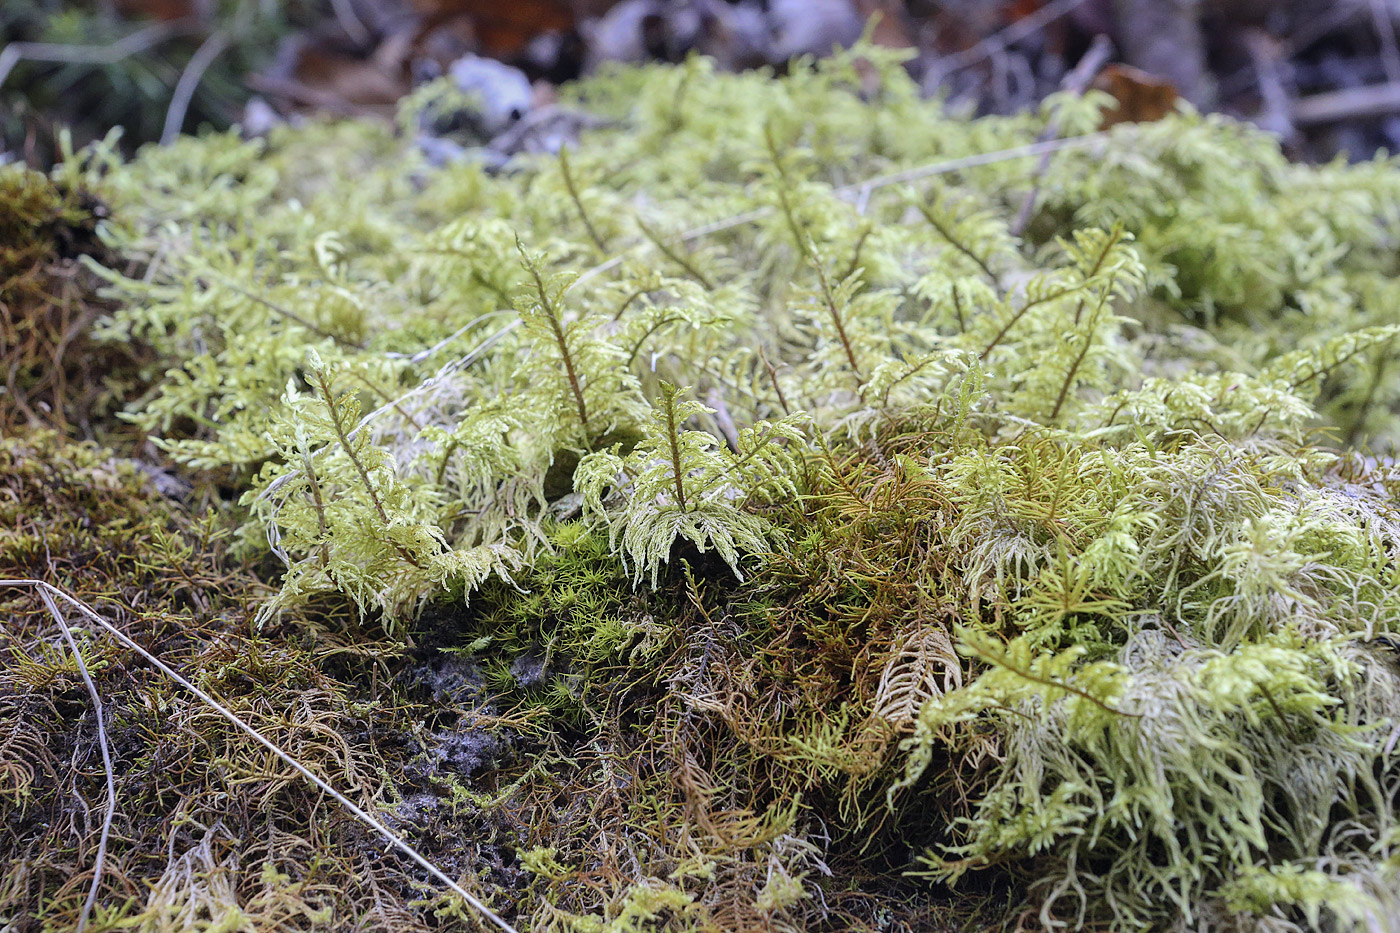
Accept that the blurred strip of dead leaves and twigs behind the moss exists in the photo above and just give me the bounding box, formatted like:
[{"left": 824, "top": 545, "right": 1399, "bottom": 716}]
[{"left": 8, "top": 0, "right": 1400, "bottom": 167}]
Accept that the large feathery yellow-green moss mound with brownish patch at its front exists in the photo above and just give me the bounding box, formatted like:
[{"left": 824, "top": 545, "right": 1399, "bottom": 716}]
[{"left": 21, "top": 41, "right": 1400, "bottom": 930}]
